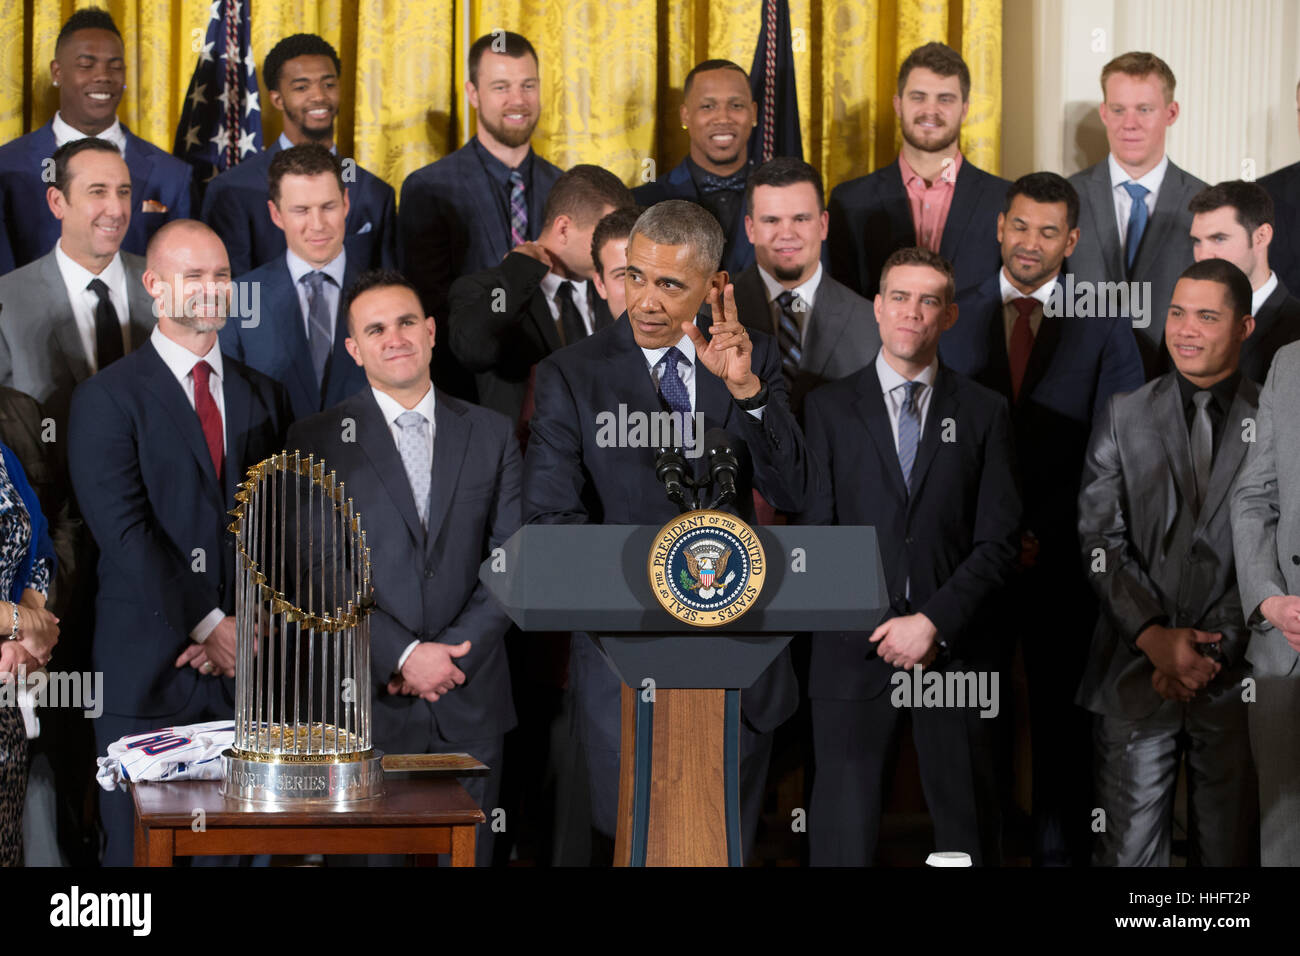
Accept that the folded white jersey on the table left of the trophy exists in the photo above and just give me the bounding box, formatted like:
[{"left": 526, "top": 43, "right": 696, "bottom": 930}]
[{"left": 95, "top": 721, "right": 235, "bottom": 791}]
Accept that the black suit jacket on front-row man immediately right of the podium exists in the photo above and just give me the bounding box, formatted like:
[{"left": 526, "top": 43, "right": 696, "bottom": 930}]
[{"left": 802, "top": 363, "right": 1021, "bottom": 700}]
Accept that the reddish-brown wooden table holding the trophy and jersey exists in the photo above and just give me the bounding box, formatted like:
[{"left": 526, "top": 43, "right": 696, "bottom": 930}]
[{"left": 131, "top": 774, "right": 486, "bottom": 866}]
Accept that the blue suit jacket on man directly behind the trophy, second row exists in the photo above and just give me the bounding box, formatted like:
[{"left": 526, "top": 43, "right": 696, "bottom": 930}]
[{"left": 218, "top": 252, "right": 365, "bottom": 420}]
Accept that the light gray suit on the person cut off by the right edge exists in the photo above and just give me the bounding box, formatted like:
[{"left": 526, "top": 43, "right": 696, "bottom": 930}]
[{"left": 1232, "top": 343, "right": 1300, "bottom": 866}]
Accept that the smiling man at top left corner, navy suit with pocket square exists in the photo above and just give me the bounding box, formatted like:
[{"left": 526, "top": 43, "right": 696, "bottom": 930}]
[{"left": 0, "top": 8, "right": 192, "bottom": 274}]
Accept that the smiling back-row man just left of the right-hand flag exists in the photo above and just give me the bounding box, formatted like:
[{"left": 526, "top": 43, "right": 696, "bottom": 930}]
[{"left": 633, "top": 60, "right": 758, "bottom": 276}]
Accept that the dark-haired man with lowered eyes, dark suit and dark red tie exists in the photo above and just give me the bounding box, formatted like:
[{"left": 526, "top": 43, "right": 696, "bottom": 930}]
[{"left": 939, "top": 173, "right": 1144, "bottom": 865}]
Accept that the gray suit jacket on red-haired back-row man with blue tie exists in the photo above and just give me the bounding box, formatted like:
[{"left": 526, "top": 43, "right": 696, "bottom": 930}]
[{"left": 1065, "top": 160, "right": 1205, "bottom": 380}]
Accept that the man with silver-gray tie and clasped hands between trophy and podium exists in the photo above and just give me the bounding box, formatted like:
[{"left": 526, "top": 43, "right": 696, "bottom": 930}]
[{"left": 287, "top": 271, "right": 520, "bottom": 865}]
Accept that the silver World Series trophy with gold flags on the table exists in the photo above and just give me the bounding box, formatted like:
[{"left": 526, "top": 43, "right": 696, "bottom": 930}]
[{"left": 215, "top": 451, "right": 384, "bottom": 806}]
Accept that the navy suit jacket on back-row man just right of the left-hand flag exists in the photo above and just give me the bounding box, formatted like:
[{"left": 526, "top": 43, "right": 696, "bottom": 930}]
[{"left": 200, "top": 140, "right": 398, "bottom": 276}]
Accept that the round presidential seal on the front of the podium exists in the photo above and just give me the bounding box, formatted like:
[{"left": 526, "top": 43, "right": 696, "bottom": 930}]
[{"left": 649, "top": 511, "right": 767, "bottom": 627}]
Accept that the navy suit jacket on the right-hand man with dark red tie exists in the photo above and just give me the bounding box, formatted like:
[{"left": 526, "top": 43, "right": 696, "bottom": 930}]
[{"left": 939, "top": 273, "right": 1145, "bottom": 561}]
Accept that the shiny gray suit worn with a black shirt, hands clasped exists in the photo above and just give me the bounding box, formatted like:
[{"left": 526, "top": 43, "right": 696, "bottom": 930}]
[{"left": 1076, "top": 372, "right": 1258, "bottom": 866}]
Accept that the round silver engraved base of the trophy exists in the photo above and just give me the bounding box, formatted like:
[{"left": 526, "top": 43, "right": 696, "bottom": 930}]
[{"left": 221, "top": 749, "right": 384, "bottom": 809}]
